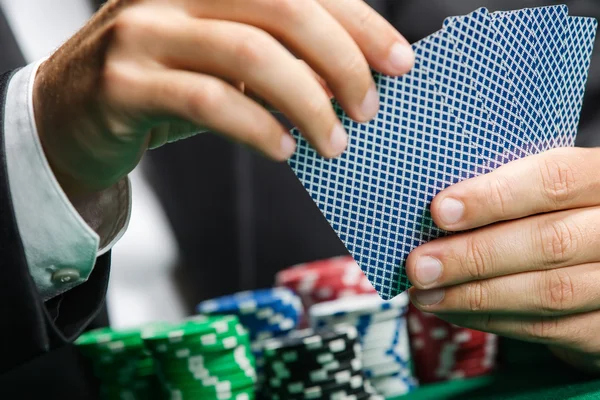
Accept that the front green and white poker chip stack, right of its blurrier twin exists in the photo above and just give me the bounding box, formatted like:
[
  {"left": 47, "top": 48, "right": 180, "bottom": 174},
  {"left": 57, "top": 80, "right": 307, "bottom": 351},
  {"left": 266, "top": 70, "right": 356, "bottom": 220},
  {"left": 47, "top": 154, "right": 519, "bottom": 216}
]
[{"left": 142, "top": 316, "right": 256, "bottom": 400}]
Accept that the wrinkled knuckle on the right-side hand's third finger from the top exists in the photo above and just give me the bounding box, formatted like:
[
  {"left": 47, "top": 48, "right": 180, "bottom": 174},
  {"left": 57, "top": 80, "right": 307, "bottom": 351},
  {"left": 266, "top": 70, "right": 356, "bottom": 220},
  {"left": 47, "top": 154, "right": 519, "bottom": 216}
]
[{"left": 540, "top": 270, "right": 575, "bottom": 314}]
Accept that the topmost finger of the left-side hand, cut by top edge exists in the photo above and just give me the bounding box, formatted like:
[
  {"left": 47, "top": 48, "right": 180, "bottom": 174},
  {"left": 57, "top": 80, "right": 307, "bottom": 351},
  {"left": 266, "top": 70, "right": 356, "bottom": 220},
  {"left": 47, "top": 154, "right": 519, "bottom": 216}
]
[{"left": 319, "top": 0, "right": 415, "bottom": 76}]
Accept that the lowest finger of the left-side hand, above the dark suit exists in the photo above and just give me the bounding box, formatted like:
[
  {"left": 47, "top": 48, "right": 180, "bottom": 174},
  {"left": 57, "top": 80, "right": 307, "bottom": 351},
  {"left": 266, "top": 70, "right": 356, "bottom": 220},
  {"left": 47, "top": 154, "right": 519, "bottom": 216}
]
[{"left": 111, "top": 65, "right": 295, "bottom": 161}]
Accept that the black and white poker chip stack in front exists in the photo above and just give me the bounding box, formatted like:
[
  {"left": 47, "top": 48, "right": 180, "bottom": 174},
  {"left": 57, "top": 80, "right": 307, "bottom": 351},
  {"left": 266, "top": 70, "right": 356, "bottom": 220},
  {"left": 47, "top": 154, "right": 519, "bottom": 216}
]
[{"left": 264, "top": 326, "right": 382, "bottom": 400}]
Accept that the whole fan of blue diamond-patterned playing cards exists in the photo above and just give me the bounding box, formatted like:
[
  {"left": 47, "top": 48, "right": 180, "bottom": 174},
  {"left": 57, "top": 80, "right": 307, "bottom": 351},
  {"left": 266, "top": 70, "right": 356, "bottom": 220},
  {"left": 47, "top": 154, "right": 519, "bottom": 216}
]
[{"left": 289, "top": 6, "right": 597, "bottom": 299}]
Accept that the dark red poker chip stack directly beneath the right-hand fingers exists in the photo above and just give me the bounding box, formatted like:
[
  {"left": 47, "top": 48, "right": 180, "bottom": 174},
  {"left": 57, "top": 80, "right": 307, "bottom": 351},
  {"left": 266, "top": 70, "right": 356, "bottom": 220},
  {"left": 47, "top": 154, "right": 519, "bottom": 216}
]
[{"left": 408, "top": 305, "right": 498, "bottom": 383}]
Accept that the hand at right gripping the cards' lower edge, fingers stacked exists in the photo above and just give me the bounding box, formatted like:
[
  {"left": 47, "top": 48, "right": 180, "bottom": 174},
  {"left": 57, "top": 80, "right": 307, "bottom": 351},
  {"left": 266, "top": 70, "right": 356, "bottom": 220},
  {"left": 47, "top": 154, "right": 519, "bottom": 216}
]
[{"left": 406, "top": 148, "right": 600, "bottom": 373}]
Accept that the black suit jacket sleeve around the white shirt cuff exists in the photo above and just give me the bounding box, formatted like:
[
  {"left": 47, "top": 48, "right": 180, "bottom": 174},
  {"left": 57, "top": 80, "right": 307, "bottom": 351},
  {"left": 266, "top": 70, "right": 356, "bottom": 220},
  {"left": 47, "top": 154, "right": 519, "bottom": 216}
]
[{"left": 0, "top": 71, "right": 110, "bottom": 373}]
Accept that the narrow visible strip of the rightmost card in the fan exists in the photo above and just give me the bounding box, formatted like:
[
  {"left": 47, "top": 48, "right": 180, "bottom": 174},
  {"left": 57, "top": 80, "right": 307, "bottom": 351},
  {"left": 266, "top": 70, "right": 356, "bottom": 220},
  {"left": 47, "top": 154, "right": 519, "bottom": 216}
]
[{"left": 557, "top": 17, "right": 598, "bottom": 147}]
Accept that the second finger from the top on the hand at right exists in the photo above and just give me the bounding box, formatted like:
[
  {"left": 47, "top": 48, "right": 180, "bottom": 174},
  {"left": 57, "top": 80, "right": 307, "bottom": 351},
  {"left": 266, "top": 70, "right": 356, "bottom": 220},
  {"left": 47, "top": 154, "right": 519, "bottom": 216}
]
[{"left": 406, "top": 207, "right": 600, "bottom": 289}]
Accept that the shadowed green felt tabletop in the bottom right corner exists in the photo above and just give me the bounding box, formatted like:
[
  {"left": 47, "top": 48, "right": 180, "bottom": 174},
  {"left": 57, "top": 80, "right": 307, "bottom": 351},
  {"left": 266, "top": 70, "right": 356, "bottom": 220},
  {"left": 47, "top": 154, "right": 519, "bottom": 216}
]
[{"left": 393, "top": 340, "right": 600, "bottom": 400}]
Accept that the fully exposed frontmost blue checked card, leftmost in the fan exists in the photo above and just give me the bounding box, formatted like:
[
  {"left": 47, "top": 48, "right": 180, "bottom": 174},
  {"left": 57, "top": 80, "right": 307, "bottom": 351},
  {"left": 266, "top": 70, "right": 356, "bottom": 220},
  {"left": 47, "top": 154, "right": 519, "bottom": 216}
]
[{"left": 289, "top": 58, "right": 477, "bottom": 300}]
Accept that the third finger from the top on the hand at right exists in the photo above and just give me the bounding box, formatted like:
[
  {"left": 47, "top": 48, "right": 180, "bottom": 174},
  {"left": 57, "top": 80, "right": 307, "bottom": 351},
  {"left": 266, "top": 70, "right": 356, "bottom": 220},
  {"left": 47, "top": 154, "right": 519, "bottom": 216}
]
[{"left": 409, "top": 263, "right": 600, "bottom": 317}]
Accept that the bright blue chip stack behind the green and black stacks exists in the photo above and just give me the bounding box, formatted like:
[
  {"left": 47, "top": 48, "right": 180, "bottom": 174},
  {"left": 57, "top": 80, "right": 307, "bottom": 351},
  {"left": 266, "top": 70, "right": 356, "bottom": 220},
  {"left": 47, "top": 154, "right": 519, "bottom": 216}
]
[{"left": 197, "top": 288, "right": 302, "bottom": 386}]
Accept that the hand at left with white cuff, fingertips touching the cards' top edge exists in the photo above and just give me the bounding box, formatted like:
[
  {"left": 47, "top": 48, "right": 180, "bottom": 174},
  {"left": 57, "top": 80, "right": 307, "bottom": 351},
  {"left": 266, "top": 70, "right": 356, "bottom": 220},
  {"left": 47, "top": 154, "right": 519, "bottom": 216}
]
[{"left": 34, "top": 0, "right": 414, "bottom": 196}]
